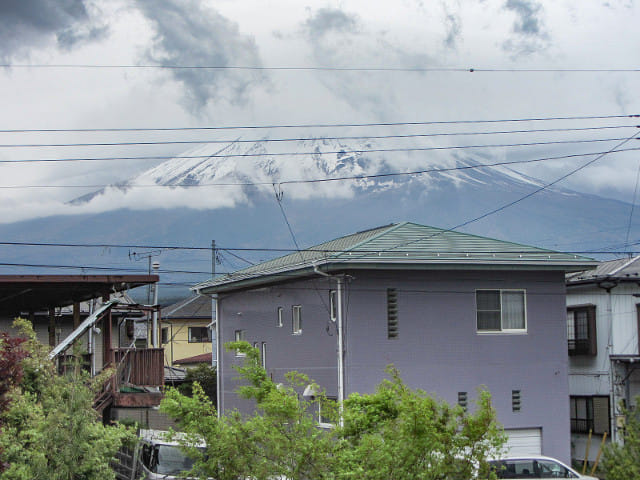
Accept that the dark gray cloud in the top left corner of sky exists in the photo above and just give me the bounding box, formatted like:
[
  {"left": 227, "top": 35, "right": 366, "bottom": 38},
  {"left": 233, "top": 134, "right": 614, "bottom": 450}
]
[{"left": 0, "top": 0, "right": 107, "bottom": 62}]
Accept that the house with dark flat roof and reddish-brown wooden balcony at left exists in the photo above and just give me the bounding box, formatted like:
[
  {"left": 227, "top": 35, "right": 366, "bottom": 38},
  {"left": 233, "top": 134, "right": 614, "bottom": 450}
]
[{"left": 0, "top": 275, "right": 166, "bottom": 426}]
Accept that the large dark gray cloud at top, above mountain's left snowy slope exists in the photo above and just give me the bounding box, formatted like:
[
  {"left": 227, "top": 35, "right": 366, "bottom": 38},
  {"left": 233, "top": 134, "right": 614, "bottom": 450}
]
[{"left": 137, "top": 0, "right": 266, "bottom": 113}]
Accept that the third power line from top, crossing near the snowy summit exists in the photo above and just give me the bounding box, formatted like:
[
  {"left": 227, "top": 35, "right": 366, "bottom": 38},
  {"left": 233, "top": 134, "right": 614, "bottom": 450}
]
[{"left": 0, "top": 125, "right": 640, "bottom": 148}]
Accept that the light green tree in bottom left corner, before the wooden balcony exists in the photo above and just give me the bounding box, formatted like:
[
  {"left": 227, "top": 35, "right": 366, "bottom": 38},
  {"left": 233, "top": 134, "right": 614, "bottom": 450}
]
[{"left": 0, "top": 320, "right": 133, "bottom": 480}]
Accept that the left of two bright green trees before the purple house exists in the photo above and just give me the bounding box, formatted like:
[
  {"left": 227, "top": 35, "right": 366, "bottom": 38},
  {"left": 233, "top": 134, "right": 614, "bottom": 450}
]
[{"left": 161, "top": 342, "right": 335, "bottom": 480}]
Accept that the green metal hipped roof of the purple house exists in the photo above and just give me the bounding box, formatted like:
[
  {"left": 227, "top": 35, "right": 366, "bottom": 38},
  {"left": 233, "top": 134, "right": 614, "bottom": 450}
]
[{"left": 193, "top": 222, "right": 597, "bottom": 293}]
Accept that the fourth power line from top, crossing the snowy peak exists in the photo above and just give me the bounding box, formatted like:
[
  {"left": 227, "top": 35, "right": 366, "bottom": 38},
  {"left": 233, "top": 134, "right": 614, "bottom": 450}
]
[{"left": 0, "top": 134, "right": 635, "bottom": 163}]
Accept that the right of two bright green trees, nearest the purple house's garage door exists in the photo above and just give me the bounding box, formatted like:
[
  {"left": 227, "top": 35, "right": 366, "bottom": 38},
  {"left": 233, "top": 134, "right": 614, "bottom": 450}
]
[{"left": 338, "top": 367, "right": 505, "bottom": 480}]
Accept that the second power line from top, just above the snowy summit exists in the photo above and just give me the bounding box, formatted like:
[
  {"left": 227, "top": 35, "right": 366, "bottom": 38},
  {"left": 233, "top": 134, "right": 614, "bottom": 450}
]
[{"left": 0, "top": 114, "right": 640, "bottom": 133}]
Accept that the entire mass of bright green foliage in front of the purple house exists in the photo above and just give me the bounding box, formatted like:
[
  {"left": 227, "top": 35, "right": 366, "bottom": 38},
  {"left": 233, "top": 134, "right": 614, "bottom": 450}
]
[{"left": 161, "top": 342, "right": 505, "bottom": 480}]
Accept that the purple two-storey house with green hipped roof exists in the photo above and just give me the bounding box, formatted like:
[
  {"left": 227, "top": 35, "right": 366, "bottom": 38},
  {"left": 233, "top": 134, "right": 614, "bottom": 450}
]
[{"left": 194, "top": 223, "right": 597, "bottom": 461}]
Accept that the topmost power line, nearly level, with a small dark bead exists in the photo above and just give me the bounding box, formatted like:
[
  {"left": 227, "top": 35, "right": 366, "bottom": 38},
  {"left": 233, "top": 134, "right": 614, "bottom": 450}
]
[{"left": 0, "top": 63, "right": 640, "bottom": 73}]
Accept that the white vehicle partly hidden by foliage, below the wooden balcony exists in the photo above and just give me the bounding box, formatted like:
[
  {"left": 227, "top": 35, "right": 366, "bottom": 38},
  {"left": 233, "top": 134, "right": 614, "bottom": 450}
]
[{"left": 113, "top": 430, "right": 205, "bottom": 480}]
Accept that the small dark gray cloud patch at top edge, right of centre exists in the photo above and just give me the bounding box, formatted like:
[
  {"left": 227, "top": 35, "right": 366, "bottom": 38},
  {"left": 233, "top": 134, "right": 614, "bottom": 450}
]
[{"left": 502, "top": 0, "right": 549, "bottom": 56}]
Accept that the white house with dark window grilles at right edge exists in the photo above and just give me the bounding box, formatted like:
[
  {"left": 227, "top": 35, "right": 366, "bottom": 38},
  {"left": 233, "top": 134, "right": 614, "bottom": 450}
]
[{"left": 566, "top": 257, "right": 640, "bottom": 461}]
